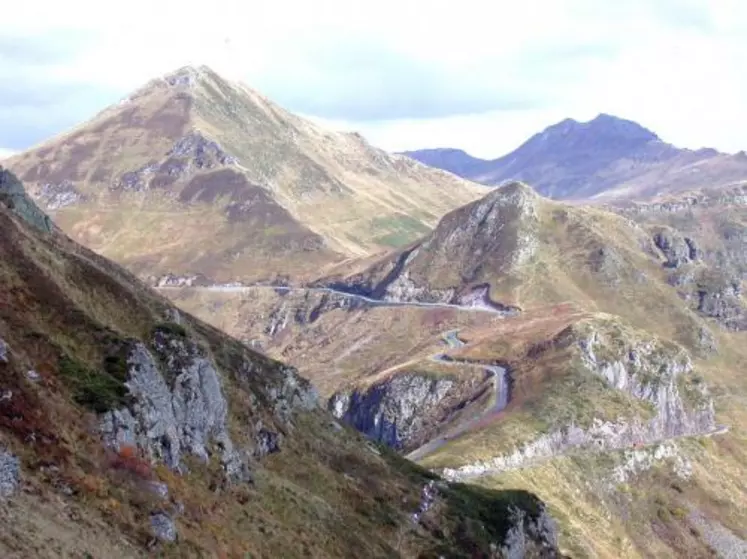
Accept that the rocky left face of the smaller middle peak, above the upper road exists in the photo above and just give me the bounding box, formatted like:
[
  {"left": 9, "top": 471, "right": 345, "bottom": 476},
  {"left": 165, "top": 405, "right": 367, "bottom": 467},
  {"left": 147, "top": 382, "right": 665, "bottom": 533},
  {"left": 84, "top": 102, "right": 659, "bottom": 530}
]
[{"left": 328, "top": 183, "right": 540, "bottom": 311}]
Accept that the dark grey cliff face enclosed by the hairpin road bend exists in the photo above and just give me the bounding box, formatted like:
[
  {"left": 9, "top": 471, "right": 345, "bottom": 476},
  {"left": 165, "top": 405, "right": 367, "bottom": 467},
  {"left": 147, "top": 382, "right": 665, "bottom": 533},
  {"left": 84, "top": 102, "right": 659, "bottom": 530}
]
[{"left": 328, "top": 374, "right": 455, "bottom": 449}]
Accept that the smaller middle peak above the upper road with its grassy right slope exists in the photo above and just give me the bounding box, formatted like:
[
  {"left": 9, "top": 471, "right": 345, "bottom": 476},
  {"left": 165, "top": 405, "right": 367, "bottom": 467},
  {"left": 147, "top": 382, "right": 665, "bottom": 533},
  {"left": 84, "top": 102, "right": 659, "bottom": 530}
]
[{"left": 324, "top": 183, "right": 745, "bottom": 351}]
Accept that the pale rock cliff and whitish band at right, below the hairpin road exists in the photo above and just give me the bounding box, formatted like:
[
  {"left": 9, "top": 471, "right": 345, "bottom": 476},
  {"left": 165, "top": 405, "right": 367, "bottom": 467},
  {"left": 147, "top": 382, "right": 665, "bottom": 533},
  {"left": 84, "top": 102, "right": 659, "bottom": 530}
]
[{"left": 443, "top": 325, "right": 716, "bottom": 480}]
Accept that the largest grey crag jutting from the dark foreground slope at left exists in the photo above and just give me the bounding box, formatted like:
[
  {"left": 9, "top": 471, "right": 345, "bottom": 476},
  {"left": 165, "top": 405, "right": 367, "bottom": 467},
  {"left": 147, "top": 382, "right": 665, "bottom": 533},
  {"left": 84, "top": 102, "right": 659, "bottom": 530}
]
[{"left": 101, "top": 331, "right": 250, "bottom": 479}]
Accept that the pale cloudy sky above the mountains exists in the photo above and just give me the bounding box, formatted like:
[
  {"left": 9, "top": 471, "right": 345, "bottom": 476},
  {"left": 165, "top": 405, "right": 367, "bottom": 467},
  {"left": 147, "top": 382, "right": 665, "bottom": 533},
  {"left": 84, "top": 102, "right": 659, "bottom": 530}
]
[{"left": 0, "top": 0, "right": 747, "bottom": 158}]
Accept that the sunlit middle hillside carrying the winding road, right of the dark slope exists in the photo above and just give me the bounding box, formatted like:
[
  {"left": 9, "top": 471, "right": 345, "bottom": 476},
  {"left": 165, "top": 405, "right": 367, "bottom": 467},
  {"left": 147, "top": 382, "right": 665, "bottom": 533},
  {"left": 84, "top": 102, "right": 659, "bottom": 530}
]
[{"left": 169, "top": 183, "right": 747, "bottom": 558}]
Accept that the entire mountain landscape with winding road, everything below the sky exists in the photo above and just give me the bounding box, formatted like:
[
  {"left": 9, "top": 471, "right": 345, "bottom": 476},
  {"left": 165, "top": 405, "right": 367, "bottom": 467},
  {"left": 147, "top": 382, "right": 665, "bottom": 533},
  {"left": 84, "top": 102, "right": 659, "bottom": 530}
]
[{"left": 0, "top": 61, "right": 747, "bottom": 559}]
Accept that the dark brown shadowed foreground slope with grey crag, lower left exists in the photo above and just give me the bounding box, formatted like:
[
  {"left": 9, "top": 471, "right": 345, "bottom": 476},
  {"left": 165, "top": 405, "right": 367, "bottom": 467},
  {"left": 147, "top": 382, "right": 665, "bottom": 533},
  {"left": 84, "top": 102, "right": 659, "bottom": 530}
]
[{"left": 0, "top": 170, "right": 557, "bottom": 558}]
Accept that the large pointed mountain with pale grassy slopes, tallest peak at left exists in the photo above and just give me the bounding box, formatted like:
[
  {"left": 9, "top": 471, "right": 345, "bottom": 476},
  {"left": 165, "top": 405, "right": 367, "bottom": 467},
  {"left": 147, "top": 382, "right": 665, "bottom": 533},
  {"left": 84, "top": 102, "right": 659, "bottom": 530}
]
[{"left": 6, "top": 67, "right": 482, "bottom": 281}]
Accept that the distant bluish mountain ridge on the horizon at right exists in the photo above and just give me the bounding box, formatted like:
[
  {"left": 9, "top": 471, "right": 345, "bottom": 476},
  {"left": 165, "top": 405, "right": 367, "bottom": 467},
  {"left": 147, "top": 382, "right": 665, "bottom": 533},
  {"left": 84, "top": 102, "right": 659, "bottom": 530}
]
[{"left": 406, "top": 114, "right": 747, "bottom": 200}]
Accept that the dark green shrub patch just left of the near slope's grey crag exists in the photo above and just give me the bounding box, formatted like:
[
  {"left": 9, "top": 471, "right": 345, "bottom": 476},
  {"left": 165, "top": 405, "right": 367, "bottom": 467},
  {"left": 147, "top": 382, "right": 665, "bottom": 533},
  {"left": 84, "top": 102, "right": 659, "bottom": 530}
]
[{"left": 59, "top": 356, "right": 130, "bottom": 413}]
